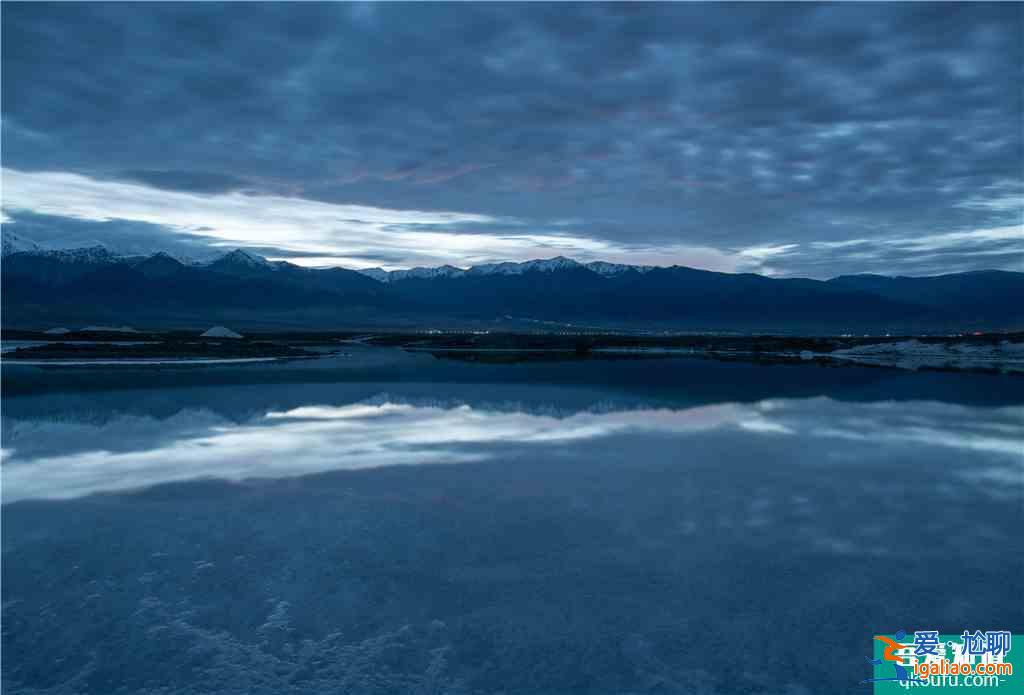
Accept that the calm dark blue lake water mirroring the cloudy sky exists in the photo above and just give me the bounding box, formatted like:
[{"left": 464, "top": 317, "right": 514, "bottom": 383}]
[{"left": 2, "top": 357, "right": 1024, "bottom": 694}]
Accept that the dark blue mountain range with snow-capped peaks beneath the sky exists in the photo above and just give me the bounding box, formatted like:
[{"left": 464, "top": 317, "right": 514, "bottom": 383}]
[{"left": 2, "top": 233, "right": 1024, "bottom": 333}]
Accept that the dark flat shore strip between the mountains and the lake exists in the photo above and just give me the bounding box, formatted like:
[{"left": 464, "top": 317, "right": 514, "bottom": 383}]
[{"left": 3, "top": 331, "right": 1024, "bottom": 374}]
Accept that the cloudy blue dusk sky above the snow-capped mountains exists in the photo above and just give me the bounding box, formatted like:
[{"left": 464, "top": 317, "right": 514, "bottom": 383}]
[{"left": 0, "top": 2, "right": 1024, "bottom": 277}]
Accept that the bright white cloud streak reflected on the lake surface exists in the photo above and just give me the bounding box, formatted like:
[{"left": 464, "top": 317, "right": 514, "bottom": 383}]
[{"left": 2, "top": 385, "right": 1024, "bottom": 503}]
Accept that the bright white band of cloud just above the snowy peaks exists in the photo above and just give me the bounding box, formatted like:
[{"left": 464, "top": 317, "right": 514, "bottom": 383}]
[{"left": 3, "top": 169, "right": 757, "bottom": 270}]
